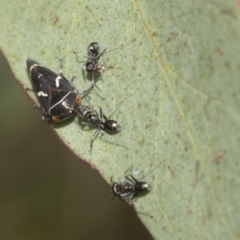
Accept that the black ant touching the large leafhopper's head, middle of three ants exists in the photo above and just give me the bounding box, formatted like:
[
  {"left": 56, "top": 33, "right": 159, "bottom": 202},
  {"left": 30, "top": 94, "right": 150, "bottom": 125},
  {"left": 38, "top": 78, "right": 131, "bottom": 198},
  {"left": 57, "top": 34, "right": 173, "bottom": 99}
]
[{"left": 78, "top": 105, "right": 121, "bottom": 152}]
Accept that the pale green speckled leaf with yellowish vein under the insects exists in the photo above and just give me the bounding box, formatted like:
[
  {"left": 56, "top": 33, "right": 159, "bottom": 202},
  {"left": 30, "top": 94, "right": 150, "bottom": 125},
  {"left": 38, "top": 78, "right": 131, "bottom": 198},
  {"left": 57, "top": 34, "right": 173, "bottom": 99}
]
[{"left": 0, "top": 0, "right": 240, "bottom": 239}]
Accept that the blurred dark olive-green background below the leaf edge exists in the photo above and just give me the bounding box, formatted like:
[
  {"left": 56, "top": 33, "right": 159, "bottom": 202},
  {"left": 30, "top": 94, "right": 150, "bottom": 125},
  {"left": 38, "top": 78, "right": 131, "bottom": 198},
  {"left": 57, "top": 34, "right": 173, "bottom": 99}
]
[{"left": 0, "top": 54, "right": 152, "bottom": 240}]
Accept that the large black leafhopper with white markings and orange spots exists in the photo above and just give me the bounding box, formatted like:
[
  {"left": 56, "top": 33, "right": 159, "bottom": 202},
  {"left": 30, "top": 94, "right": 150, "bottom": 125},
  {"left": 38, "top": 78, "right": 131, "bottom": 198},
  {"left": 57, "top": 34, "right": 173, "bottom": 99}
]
[{"left": 27, "top": 59, "right": 93, "bottom": 122}]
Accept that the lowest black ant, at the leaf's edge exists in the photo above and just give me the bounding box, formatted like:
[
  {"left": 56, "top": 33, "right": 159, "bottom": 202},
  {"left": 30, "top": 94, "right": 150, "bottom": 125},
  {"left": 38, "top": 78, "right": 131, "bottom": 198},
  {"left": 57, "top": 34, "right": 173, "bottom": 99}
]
[{"left": 111, "top": 175, "right": 151, "bottom": 203}]
